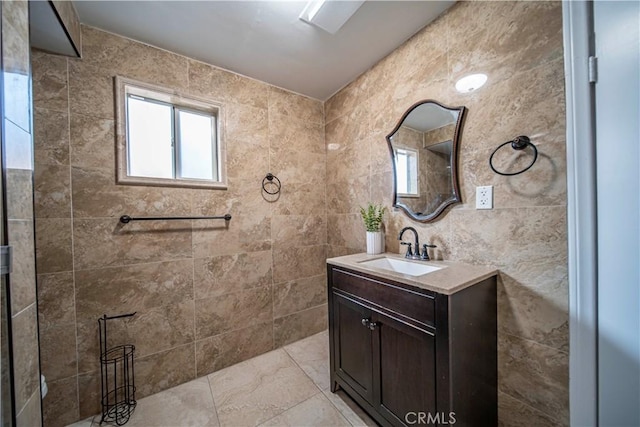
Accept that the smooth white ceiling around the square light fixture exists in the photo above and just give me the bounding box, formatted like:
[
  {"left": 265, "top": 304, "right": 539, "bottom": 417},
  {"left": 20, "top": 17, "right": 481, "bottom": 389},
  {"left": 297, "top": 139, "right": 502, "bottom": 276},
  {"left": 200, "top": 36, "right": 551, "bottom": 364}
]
[{"left": 74, "top": 0, "right": 455, "bottom": 100}]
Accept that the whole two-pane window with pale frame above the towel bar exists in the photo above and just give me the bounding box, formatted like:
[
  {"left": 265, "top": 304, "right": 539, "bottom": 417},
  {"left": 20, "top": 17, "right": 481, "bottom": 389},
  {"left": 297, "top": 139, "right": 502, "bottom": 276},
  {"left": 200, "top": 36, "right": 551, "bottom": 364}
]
[{"left": 116, "top": 77, "right": 226, "bottom": 188}]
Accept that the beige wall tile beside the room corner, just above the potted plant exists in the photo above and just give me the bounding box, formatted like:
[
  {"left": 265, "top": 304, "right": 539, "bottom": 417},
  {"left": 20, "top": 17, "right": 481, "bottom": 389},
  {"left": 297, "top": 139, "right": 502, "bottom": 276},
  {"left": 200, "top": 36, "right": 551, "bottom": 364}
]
[{"left": 327, "top": 176, "right": 372, "bottom": 215}]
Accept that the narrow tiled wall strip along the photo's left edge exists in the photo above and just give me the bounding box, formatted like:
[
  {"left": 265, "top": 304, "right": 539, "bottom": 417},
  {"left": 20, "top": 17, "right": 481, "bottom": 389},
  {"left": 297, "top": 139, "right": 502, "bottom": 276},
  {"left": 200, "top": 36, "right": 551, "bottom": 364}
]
[{"left": 0, "top": 1, "right": 41, "bottom": 427}]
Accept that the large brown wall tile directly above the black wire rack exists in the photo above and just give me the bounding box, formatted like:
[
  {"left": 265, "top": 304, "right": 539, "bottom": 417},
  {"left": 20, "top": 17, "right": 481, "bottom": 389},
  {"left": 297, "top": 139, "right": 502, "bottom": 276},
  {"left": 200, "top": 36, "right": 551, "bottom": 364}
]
[{"left": 75, "top": 259, "right": 193, "bottom": 322}]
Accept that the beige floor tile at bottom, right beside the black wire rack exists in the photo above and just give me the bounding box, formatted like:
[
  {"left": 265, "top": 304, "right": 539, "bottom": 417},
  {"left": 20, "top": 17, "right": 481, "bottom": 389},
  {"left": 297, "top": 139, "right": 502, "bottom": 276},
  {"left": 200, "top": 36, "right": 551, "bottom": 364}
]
[{"left": 127, "top": 377, "right": 220, "bottom": 427}]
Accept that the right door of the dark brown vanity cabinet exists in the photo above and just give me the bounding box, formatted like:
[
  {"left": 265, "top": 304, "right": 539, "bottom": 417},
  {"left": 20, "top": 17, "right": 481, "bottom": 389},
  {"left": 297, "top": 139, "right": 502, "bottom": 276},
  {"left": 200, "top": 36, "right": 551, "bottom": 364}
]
[{"left": 372, "top": 314, "right": 441, "bottom": 425}]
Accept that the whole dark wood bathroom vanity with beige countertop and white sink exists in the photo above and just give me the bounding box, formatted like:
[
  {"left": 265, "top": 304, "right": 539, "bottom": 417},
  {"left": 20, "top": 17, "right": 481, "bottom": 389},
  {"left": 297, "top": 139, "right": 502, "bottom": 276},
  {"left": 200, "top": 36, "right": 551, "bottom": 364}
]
[{"left": 327, "top": 254, "right": 498, "bottom": 426}]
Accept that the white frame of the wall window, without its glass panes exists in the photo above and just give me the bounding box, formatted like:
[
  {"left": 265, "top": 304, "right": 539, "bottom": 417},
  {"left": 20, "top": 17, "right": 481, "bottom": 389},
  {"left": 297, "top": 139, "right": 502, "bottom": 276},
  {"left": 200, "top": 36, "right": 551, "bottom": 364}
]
[{"left": 115, "top": 76, "right": 227, "bottom": 190}]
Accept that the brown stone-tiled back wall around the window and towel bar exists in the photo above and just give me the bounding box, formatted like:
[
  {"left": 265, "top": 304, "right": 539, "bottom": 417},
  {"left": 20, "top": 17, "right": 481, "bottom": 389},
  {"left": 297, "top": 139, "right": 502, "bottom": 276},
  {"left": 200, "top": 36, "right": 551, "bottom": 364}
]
[{"left": 33, "top": 26, "right": 327, "bottom": 426}]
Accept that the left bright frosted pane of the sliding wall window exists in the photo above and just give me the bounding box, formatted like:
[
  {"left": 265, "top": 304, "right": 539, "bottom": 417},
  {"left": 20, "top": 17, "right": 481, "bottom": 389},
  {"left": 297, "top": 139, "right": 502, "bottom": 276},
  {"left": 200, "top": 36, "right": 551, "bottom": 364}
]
[{"left": 127, "top": 96, "right": 173, "bottom": 178}]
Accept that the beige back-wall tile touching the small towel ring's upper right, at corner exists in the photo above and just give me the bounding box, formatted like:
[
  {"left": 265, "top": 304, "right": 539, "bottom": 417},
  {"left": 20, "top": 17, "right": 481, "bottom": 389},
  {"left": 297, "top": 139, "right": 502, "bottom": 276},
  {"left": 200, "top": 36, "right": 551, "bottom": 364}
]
[{"left": 270, "top": 148, "right": 326, "bottom": 186}]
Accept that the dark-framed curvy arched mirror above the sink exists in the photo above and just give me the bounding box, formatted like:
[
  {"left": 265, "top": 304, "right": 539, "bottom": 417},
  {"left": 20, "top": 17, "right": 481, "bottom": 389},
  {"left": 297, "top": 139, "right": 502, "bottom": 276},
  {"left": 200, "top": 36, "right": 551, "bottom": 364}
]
[{"left": 387, "top": 100, "right": 466, "bottom": 222}]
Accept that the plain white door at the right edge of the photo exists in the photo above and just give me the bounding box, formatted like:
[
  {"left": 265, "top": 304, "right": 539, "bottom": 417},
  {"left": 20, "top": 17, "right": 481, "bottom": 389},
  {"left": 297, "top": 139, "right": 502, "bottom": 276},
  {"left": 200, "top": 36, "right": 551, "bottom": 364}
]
[{"left": 596, "top": 1, "right": 640, "bottom": 426}]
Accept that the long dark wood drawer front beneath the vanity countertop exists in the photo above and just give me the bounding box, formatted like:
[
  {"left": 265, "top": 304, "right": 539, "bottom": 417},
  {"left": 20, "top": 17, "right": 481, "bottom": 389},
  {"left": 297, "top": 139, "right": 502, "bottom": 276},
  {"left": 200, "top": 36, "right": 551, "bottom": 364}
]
[{"left": 331, "top": 268, "right": 435, "bottom": 327}]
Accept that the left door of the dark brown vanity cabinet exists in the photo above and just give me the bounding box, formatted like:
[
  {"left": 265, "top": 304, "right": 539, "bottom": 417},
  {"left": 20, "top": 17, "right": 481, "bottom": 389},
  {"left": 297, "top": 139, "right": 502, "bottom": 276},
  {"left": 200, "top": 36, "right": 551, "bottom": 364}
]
[{"left": 333, "top": 293, "right": 373, "bottom": 401}]
